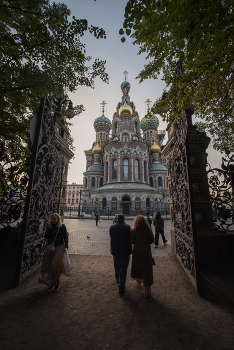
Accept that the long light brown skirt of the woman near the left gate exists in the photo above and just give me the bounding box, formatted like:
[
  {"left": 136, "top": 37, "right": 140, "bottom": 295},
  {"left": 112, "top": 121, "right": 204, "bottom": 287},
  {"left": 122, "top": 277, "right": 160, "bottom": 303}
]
[{"left": 38, "top": 244, "right": 65, "bottom": 286}]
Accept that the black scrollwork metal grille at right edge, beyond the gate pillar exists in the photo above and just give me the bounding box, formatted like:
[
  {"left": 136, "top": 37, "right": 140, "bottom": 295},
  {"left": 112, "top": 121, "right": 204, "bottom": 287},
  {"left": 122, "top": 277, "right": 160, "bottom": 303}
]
[{"left": 207, "top": 154, "right": 234, "bottom": 231}]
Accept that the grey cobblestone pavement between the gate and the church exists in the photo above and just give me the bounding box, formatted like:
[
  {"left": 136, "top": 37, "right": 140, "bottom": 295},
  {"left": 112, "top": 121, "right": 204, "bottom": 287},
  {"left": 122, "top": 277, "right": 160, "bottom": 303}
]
[{"left": 64, "top": 219, "right": 171, "bottom": 256}]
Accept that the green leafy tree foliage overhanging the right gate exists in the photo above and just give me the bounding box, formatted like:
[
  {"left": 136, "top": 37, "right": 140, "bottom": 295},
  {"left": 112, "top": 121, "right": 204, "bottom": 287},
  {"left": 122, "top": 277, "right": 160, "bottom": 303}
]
[{"left": 120, "top": 0, "right": 234, "bottom": 151}]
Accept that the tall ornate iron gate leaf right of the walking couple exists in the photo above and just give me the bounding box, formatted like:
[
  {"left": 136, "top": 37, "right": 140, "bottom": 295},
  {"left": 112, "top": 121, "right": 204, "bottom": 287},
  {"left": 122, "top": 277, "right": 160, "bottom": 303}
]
[{"left": 169, "top": 113, "right": 198, "bottom": 289}]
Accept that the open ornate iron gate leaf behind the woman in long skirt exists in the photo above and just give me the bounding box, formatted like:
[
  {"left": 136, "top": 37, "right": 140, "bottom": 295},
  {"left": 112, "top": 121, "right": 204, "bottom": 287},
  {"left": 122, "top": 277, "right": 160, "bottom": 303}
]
[{"left": 16, "top": 97, "right": 62, "bottom": 284}]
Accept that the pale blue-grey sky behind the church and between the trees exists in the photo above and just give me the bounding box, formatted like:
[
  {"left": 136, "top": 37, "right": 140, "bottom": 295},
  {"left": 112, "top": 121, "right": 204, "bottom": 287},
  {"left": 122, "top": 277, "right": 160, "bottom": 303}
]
[{"left": 54, "top": 0, "right": 222, "bottom": 184}]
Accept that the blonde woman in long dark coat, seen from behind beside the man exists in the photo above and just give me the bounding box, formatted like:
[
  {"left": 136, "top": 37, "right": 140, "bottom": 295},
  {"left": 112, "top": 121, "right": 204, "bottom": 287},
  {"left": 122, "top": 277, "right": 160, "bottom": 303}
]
[{"left": 130, "top": 215, "right": 154, "bottom": 298}]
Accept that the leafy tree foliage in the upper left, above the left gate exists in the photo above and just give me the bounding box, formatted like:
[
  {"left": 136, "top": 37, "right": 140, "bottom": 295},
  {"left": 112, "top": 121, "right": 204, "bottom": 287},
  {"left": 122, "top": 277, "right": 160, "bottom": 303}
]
[{"left": 0, "top": 0, "right": 108, "bottom": 175}]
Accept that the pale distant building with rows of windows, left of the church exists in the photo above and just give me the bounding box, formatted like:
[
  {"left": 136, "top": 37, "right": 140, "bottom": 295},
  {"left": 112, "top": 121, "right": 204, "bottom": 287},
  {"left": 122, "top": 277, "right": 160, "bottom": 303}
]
[{"left": 65, "top": 182, "right": 83, "bottom": 211}]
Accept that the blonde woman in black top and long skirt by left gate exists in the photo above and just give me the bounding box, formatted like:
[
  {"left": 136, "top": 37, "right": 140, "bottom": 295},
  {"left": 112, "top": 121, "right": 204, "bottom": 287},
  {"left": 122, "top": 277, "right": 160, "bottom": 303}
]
[{"left": 38, "top": 213, "right": 68, "bottom": 292}]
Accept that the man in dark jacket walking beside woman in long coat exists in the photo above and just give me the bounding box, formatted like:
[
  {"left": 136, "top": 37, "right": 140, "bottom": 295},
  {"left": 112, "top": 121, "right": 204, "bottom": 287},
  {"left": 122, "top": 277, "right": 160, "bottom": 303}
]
[{"left": 110, "top": 214, "right": 132, "bottom": 295}]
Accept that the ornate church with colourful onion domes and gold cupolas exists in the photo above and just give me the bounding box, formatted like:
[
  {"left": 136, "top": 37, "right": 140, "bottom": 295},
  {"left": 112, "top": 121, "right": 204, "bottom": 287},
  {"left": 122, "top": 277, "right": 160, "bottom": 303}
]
[{"left": 82, "top": 78, "right": 168, "bottom": 216}]
